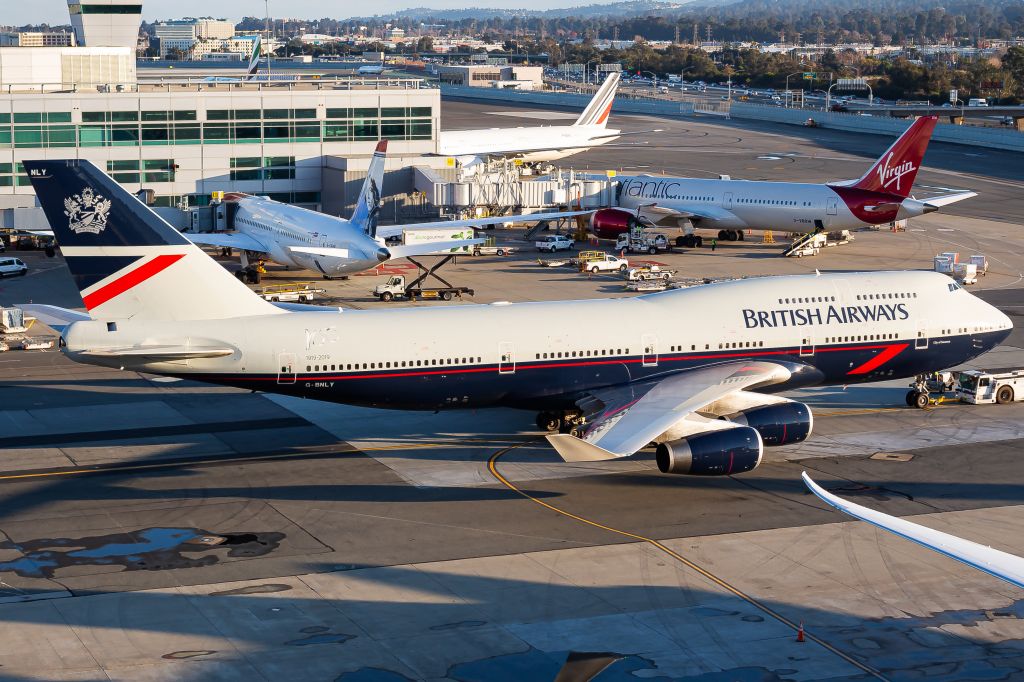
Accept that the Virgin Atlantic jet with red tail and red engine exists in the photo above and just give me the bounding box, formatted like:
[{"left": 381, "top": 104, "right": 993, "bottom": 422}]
[{"left": 592, "top": 116, "right": 977, "bottom": 247}]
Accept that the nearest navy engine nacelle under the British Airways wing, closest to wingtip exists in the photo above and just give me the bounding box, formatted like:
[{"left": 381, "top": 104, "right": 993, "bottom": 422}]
[{"left": 654, "top": 426, "right": 764, "bottom": 476}]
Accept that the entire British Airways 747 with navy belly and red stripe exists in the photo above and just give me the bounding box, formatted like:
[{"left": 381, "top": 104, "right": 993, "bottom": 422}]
[{"left": 25, "top": 160, "right": 1012, "bottom": 475}]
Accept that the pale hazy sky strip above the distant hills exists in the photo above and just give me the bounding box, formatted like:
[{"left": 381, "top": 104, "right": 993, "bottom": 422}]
[{"left": 8, "top": 0, "right": 598, "bottom": 26}]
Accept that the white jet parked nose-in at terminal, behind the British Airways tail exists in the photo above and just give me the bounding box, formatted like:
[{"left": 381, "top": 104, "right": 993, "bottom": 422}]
[{"left": 188, "top": 140, "right": 589, "bottom": 279}]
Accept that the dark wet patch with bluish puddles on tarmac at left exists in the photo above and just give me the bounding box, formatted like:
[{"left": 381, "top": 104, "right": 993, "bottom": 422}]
[{"left": 0, "top": 527, "right": 285, "bottom": 579}]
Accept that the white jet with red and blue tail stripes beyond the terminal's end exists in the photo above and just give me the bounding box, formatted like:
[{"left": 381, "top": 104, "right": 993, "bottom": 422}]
[{"left": 437, "top": 74, "right": 630, "bottom": 166}]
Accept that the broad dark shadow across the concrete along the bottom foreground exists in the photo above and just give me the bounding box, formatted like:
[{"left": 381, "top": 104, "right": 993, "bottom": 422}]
[{"left": 0, "top": 563, "right": 1024, "bottom": 682}]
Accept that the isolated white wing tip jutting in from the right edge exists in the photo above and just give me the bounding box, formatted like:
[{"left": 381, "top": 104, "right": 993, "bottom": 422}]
[{"left": 801, "top": 471, "right": 1024, "bottom": 587}]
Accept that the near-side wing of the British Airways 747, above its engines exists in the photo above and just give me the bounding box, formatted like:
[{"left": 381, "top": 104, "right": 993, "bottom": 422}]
[{"left": 548, "top": 361, "right": 791, "bottom": 462}]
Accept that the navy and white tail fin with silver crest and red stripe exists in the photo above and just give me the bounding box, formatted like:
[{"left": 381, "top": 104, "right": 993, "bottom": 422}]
[{"left": 24, "top": 159, "right": 283, "bottom": 319}]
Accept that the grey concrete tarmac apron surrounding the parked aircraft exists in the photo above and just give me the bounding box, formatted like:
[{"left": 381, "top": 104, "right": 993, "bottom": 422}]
[{"left": 0, "top": 102, "right": 1024, "bottom": 682}]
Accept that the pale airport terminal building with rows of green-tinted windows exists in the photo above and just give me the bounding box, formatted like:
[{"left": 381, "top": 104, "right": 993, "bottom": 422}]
[{"left": 0, "top": 1, "right": 440, "bottom": 228}]
